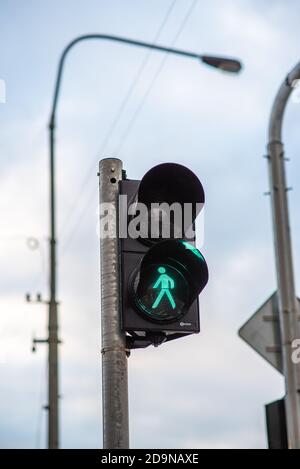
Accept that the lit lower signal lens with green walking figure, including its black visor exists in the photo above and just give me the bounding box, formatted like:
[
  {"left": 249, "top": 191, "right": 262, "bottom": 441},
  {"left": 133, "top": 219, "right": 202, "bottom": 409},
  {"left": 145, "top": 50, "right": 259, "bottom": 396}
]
[{"left": 131, "top": 240, "right": 207, "bottom": 323}]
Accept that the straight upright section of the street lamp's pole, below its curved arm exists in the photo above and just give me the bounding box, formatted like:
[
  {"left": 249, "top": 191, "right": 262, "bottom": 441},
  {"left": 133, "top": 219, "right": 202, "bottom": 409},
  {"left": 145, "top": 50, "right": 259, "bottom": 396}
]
[{"left": 48, "top": 123, "right": 59, "bottom": 449}]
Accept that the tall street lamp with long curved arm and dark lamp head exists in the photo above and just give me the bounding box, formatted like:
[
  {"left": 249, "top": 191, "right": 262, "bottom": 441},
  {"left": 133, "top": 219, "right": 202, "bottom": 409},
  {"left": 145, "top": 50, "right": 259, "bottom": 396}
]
[{"left": 48, "top": 34, "right": 242, "bottom": 448}]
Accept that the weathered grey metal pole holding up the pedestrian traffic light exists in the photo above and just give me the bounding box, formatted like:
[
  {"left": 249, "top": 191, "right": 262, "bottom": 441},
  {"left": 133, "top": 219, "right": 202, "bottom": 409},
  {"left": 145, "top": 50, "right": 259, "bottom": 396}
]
[{"left": 99, "top": 158, "right": 129, "bottom": 449}]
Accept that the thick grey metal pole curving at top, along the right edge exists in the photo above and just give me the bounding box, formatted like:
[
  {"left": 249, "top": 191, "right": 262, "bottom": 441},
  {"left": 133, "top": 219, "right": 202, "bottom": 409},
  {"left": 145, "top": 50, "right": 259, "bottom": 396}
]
[{"left": 268, "top": 63, "right": 300, "bottom": 449}]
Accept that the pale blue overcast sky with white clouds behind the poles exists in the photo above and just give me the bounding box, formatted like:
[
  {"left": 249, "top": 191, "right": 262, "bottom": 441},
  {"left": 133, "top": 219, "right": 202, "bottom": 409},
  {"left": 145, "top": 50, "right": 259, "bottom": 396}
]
[{"left": 0, "top": 0, "right": 300, "bottom": 448}]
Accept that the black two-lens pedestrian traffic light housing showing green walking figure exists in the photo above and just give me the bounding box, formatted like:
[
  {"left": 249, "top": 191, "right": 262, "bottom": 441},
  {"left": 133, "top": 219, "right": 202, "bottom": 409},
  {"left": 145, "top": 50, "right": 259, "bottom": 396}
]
[{"left": 119, "top": 163, "right": 208, "bottom": 348}]
